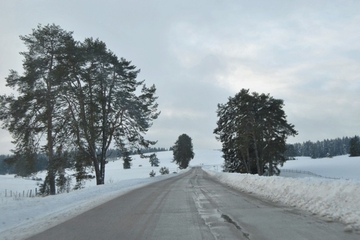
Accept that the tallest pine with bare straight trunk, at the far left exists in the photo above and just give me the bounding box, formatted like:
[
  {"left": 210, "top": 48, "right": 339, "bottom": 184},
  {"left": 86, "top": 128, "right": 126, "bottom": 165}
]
[{"left": 0, "top": 25, "right": 74, "bottom": 194}]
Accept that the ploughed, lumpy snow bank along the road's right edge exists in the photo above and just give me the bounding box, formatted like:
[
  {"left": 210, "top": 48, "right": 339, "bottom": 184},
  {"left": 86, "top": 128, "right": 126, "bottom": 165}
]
[{"left": 207, "top": 171, "right": 360, "bottom": 230}]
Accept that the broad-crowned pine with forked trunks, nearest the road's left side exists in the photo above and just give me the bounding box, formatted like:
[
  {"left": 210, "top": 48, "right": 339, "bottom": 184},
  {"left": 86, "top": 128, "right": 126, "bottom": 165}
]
[{"left": 58, "top": 38, "right": 159, "bottom": 184}]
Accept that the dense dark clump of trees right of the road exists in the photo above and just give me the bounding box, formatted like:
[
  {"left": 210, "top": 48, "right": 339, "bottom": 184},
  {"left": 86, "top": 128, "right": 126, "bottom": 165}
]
[{"left": 214, "top": 89, "right": 297, "bottom": 175}]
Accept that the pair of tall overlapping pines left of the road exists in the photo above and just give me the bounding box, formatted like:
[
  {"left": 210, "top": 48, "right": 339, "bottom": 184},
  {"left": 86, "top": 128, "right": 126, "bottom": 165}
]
[{"left": 0, "top": 25, "right": 159, "bottom": 194}]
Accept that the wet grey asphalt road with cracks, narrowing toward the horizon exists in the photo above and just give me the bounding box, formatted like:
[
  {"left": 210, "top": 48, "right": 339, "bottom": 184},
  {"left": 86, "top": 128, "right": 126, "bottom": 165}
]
[{"left": 30, "top": 168, "right": 360, "bottom": 240}]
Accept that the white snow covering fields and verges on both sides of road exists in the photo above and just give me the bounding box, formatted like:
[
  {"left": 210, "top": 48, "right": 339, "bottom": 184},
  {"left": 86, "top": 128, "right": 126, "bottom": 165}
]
[{"left": 0, "top": 150, "right": 360, "bottom": 239}]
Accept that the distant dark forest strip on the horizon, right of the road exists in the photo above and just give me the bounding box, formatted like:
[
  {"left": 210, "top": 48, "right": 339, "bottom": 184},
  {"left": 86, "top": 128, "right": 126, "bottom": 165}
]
[{"left": 286, "top": 137, "right": 352, "bottom": 158}]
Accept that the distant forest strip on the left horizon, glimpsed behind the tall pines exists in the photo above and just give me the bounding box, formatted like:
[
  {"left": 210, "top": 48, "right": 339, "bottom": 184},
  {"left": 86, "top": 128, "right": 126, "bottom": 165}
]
[{"left": 0, "top": 147, "right": 168, "bottom": 176}]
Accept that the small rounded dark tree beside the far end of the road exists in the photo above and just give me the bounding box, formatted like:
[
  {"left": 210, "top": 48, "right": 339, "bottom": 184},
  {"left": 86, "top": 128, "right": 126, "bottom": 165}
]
[{"left": 172, "top": 134, "right": 195, "bottom": 169}]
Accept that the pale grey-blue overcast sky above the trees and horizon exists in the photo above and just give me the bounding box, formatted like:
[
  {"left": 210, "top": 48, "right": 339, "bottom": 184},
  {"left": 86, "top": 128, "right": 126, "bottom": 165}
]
[{"left": 0, "top": 0, "right": 360, "bottom": 153}]
